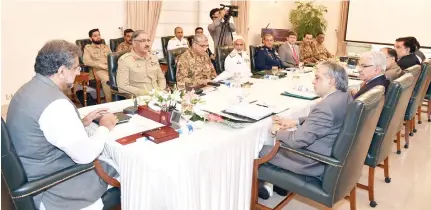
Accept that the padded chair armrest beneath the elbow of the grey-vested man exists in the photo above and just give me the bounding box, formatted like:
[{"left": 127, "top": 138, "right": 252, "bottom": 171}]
[{"left": 11, "top": 163, "right": 94, "bottom": 199}]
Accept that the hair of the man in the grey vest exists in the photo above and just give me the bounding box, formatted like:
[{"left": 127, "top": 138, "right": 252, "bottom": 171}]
[{"left": 34, "top": 40, "right": 82, "bottom": 76}]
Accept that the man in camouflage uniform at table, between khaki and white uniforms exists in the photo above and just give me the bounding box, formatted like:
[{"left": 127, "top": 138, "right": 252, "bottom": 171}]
[{"left": 177, "top": 34, "right": 217, "bottom": 87}]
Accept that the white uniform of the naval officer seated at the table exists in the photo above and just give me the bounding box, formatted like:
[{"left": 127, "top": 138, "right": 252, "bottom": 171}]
[{"left": 214, "top": 49, "right": 253, "bottom": 82}]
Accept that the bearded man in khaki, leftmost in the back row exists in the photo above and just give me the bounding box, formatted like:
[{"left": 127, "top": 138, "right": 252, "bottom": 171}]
[{"left": 83, "top": 29, "right": 112, "bottom": 102}]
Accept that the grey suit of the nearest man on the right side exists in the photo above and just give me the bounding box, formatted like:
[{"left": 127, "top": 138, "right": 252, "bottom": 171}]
[{"left": 261, "top": 90, "right": 352, "bottom": 177}]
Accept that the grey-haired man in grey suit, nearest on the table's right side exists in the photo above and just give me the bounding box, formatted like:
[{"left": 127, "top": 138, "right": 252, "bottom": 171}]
[{"left": 259, "top": 61, "right": 352, "bottom": 199}]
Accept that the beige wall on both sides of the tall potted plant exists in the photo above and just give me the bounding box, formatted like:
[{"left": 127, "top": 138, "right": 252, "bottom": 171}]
[{"left": 248, "top": 0, "right": 340, "bottom": 54}]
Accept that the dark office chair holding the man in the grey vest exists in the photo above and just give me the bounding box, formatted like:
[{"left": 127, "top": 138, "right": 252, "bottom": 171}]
[{"left": 1, "top": 118, "right": 121, "bottom": 210}]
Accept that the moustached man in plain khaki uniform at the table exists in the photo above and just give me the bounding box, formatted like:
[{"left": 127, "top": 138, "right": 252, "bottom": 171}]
[{"left": 117, "top": 30, "right": 166, "bottom": 96}]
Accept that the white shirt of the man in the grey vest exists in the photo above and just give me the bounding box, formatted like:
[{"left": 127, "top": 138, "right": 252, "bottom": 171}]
[{"left": 39, "top": 99, "right": 109, "bottom": 210}]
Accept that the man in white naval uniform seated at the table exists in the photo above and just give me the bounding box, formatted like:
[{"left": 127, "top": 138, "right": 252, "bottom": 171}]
[{"left": 214, "top": 35, "right": 253, "bottom": 82}]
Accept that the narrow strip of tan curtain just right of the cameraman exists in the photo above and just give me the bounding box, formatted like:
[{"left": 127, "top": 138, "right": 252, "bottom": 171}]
[{"left": 232, "top": 0, "right": 250, "bottom": 44}]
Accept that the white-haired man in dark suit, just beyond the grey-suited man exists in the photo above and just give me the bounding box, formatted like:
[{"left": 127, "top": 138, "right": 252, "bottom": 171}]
[{"left": 351, "top": 51, "right": 390, "bottom": 99}]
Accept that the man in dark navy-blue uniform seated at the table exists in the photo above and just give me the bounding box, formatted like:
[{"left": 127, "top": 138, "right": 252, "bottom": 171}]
[{"left": 255, "top": 34, "right": 282, "bottom": 71}]
